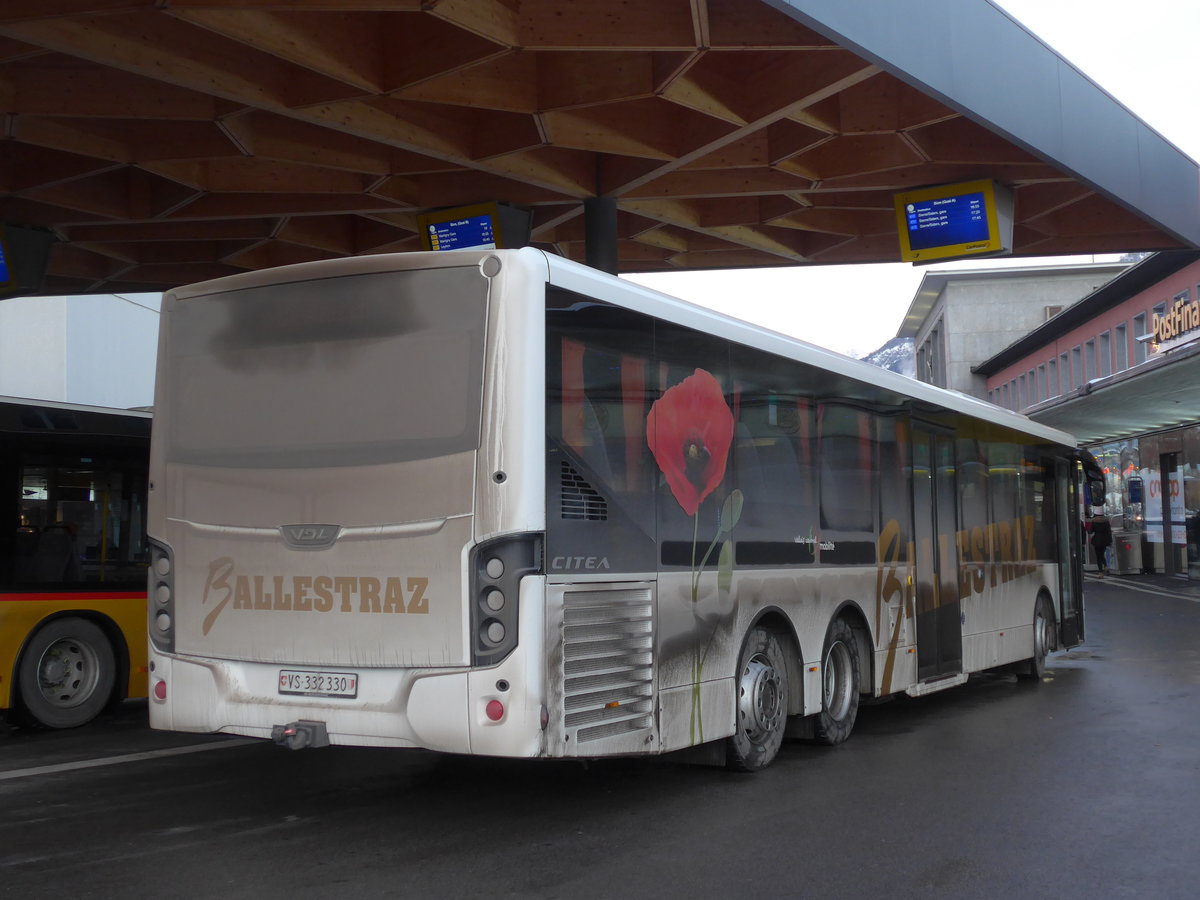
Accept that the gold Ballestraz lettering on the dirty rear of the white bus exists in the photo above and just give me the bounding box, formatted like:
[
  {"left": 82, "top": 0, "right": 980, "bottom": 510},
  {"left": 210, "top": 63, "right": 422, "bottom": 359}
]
[{"left": 202, "top": 557, "right": 430, "bottom": 635}]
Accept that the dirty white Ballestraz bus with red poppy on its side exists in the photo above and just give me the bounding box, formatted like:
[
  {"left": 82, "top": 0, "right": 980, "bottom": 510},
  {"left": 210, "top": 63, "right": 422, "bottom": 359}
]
[{"left": 142, "top": 248, "right": 1099, "bottom": 769}]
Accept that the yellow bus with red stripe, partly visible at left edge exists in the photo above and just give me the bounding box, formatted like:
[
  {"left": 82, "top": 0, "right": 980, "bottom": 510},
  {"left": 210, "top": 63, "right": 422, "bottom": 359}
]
[{"left": 0, "top": 397, "right": 150, "bottom": 728}]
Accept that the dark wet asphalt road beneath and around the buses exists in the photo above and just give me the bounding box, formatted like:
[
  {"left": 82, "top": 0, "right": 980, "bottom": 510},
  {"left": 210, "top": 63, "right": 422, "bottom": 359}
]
[{"left": 0, "top": 580, "right": 1200, "bottom": 900}]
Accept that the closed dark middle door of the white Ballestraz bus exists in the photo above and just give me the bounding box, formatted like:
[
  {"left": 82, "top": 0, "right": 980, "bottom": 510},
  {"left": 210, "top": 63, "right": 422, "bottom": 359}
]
[{"left": 912, "top": 426, "right": 962, "bottom": 680}]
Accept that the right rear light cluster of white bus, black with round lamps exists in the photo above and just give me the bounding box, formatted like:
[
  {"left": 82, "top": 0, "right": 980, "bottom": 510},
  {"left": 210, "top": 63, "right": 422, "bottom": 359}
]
[{"left": 470, "top": 534, "right": 542, "bottom": 672}]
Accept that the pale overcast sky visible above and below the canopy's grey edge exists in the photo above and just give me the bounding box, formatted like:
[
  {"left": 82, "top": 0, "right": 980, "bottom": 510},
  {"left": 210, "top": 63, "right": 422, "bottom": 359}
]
[{"left": 634, "top": 0, "right": 1200, "bottom": 356}]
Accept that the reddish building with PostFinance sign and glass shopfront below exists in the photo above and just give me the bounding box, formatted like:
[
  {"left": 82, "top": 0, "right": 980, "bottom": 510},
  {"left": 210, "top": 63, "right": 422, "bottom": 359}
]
[{"left": 972, "top": 251, "right": 1200, "bottom": 580}]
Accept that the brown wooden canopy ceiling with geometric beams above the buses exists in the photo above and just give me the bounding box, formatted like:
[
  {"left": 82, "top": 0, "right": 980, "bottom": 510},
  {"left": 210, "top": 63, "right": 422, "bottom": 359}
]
[{"left": 0, "top": 0, "right": 1180, "bottom": 294}]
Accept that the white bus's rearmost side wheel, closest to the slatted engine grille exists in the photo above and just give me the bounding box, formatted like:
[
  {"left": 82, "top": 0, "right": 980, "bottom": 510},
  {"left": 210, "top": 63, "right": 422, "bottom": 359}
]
[{"left": 726, "top": 626, "right": 788, "bottom": 772}]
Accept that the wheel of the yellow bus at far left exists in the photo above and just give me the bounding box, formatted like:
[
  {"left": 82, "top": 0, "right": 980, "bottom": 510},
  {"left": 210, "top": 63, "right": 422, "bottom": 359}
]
[{"left": 17, "top": 618, "right": 116, "bottom": 728}]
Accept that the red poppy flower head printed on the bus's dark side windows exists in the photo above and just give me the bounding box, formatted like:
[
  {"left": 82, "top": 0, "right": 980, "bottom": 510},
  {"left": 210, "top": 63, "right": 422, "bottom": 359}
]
[{"left": 646, "top": 368, "right": 733, "bottom": 516}]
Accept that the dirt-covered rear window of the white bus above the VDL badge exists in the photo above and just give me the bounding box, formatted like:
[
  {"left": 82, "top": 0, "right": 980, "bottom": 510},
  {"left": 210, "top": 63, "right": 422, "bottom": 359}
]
[{"left": 164, "top": 268, "right": 487, "bottom": 468}]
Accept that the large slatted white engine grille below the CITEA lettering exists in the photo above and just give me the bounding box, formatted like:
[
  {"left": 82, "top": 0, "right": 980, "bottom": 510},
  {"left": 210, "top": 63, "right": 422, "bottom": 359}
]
[{"left": 563, "top": 588, "right": 654, "bottom": 752}]
